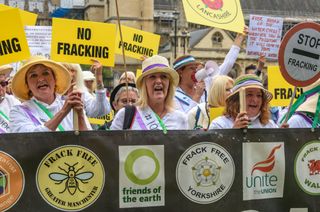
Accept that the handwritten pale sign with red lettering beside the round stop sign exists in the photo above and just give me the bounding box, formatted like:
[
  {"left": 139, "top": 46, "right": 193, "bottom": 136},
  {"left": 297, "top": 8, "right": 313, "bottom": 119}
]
[{"left": 246, "top": 15, "right": 283, "bottom": 60}]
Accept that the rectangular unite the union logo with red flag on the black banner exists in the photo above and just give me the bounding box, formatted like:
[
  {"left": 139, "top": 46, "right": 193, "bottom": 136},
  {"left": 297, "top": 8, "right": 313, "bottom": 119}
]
[{"left": 242, "top": 143, "right": 285, "bottom": 200}]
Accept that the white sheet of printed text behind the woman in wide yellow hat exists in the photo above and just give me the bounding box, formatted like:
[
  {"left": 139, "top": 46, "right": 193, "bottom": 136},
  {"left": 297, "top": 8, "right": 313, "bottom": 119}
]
[{"left": 24, "top": 26, "right": 52, "bottom": 59}]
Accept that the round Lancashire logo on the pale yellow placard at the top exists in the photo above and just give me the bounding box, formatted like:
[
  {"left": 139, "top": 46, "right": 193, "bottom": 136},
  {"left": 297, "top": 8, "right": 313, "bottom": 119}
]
[{"left": 186, "top": 0, "right": 239, "bottom": 24}]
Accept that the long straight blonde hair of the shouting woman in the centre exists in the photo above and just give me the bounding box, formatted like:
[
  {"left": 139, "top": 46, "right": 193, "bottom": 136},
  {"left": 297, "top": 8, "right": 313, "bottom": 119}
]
[{"left": 136, "top": 75, "right": 176, "bottom": 111}]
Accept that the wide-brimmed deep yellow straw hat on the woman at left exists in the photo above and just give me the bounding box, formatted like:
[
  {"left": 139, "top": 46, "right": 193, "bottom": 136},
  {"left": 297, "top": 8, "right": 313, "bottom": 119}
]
[{"left": 12, "top": 56, "right": 71, "bottom": 101}]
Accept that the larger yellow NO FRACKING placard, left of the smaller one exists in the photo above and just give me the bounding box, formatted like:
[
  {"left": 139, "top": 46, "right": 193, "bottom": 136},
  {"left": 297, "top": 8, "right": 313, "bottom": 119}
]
[{"left": 51, "top": 18, "right": 116, "bottom": 67}]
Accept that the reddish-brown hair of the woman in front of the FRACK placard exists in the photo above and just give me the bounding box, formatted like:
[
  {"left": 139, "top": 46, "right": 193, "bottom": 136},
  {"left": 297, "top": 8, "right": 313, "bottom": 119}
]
[{"left": 224, "top": 88, "right": 270, "bottom": 125}]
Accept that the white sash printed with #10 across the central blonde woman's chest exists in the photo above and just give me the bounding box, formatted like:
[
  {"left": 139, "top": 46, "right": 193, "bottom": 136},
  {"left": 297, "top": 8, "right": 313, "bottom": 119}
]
[{"left": 131, "top": 107, "right": 162, "bottom": 130}]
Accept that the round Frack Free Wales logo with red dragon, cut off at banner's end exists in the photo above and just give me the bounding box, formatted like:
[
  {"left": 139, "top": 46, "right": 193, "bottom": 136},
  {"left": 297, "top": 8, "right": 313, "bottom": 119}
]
[{"left": 294, "top": 141, "right": 320, "bottom": 195}]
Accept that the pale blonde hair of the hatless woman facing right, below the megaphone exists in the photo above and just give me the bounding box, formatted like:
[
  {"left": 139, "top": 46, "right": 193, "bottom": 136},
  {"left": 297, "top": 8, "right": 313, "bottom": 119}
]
[{"left": 208, "top": 75, "right": 234, "bottom": 107}]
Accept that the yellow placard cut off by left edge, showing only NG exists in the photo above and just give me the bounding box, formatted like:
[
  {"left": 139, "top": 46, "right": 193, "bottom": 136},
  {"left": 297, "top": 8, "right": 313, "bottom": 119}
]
[{"left": 0, "top": 9, "right": 30, "bottom": 65}]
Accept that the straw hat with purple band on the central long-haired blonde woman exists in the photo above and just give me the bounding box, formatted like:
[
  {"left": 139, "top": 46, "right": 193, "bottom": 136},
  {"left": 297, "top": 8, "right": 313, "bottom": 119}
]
[{"left": 136, "top": 55, "right": 179, "bottom": 90}]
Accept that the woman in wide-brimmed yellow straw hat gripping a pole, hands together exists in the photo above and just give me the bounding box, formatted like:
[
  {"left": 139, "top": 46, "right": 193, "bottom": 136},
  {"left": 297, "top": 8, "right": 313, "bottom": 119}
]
[{"left": 10, "top": 56, "right": 91, "bottom": 132}]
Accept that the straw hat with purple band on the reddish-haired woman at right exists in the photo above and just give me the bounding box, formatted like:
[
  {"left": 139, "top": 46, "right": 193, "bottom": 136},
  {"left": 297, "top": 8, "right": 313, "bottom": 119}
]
[{"left": 227, "top": 74, "right": 273, "bottom": 102}]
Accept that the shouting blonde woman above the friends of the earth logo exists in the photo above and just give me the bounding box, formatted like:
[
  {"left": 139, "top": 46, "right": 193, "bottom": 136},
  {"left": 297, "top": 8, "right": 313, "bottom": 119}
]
[{"left": 111, "top": 55, "right": 187, "bottom": 132}]
